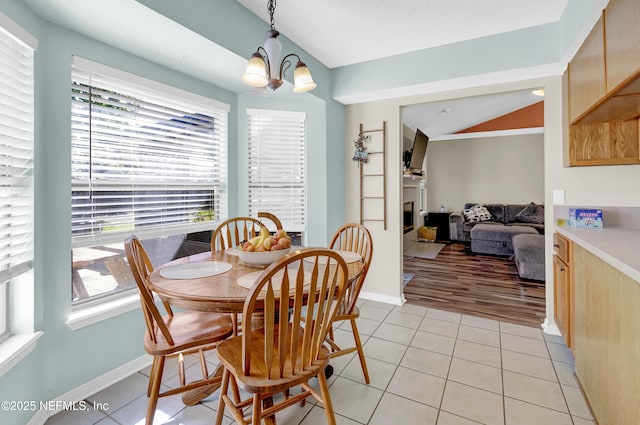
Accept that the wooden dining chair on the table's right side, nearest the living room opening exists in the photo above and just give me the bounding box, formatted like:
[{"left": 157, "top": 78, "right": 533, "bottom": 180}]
[{"left": 326, "top": 223, "right": 373, "bottom": 384}]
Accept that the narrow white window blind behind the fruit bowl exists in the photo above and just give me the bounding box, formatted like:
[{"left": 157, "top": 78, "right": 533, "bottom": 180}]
[{"left": 247, "top": 109, "right": 306, "bottom": 232}]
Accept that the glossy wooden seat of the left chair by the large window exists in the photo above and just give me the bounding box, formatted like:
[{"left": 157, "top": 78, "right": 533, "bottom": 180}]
[{"left": 144, "top": 311, "right": 233, "bottom": 356}]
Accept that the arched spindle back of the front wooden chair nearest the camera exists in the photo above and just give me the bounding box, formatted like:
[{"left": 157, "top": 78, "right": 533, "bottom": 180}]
[{"left": 242, "top": 248, "right": 349, "bottom": 379}]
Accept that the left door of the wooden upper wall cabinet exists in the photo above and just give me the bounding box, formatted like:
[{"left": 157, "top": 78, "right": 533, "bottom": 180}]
[{"left": 569, "top": 17, "right": 606, "bottom": 122}]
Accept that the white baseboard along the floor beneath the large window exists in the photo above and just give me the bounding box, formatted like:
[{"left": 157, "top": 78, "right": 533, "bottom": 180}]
[{"left": 27, "top": 354, "right": 153, "bottom": 425}]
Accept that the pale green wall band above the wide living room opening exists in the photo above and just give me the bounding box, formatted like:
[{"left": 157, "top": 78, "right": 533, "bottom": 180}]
[{"left": 333, "top": 0, "right": 603, "bottom": 99}]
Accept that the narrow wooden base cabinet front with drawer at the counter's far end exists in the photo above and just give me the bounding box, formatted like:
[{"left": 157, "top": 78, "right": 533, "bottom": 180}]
[{"left": 553, "top": 233, "right": 574, "bottom": 351}]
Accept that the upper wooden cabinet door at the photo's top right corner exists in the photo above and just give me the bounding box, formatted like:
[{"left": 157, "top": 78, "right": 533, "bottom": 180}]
[{"left": 605, "top": 0, "right": 640, "bottom": 92}]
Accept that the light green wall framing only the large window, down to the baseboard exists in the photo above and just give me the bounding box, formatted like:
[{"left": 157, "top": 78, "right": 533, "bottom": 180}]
[{"left": 0, "top": 13, "right": 237, "bottom": 423}]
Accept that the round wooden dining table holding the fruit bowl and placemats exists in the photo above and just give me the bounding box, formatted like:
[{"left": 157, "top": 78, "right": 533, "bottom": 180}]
[{"left": 149, "top": 247, "right": 363, "bottom": 405}]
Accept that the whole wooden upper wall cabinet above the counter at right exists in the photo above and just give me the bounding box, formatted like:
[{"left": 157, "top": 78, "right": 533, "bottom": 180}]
[{"left": 568, "top": 0, "right": 640, "bottom": 166}]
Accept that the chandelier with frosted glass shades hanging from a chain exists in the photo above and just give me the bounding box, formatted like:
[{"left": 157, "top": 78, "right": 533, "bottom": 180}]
[{"left": 242, "top": 0, "right": 317, "bottom": 93}]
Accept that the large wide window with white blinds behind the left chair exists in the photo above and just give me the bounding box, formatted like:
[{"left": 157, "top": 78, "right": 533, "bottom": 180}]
[{"left": 71, "top": 57, "right": 229, "bottom": 302}]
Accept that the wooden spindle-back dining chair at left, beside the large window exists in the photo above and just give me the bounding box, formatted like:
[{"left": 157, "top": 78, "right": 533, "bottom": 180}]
[{"left": 125, "top": 236, "right": 233, "bottom": 425}]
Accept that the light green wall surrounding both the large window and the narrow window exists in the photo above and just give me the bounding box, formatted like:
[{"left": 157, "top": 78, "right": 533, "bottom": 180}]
[{"left": 0, "top": 0, "right": 344, "bottom": 425}]
